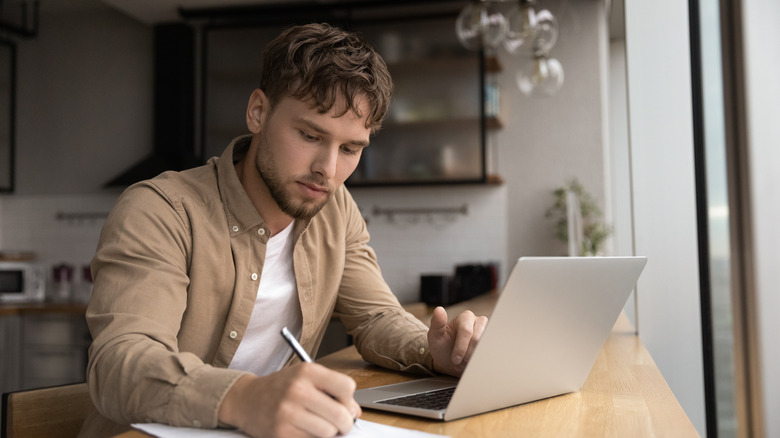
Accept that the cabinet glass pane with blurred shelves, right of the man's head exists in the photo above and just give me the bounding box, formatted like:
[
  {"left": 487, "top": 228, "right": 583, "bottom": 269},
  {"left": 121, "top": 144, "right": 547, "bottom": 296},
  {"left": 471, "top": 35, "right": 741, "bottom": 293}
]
[{"left": 349, "top": 17, "right": 485, "bottom": 185}]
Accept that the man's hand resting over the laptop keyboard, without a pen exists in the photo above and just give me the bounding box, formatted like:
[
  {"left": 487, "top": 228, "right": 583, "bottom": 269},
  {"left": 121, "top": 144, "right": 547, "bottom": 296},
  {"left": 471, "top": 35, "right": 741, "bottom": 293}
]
[{"left": 428, "top": 306, "right": 487, "bottom": 377}]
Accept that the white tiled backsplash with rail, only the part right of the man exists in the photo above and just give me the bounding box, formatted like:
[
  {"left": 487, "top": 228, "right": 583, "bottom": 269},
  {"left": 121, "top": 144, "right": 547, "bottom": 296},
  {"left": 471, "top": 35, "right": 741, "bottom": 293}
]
[{"left": 351, "top": 186, "right": 508, "bottom": 303}]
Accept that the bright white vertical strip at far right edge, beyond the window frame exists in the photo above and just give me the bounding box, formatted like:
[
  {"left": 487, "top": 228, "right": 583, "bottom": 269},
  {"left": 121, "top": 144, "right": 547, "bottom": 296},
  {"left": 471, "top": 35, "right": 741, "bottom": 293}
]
[{"left": 741, "top": 0, "right": 780, "bottom": 437}]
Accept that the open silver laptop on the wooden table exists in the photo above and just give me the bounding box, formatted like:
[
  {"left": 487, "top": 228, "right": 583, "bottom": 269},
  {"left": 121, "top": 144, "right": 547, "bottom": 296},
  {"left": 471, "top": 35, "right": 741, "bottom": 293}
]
[{"left": 355, "top": 257, "right": 647, "bottom": 421}]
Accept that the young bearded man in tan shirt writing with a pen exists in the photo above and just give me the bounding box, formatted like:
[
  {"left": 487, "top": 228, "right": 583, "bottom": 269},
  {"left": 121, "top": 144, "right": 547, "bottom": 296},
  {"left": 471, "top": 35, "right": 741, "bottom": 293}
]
[{"left": 82, "top": 25, "right": 486, "bottom": 437}]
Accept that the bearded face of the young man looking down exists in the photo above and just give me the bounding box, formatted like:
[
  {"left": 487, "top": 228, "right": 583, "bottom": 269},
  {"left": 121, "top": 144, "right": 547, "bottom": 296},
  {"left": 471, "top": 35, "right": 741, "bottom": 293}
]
[{"left": 250, "top": 91, "right": 371, "bottom": 219}]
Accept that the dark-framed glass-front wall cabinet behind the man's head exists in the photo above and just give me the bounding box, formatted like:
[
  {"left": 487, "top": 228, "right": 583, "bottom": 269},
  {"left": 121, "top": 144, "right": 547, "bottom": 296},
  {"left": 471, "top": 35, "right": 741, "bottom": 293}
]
[{"left": 200, "top": 5, "right": 499, "bottom": 187}]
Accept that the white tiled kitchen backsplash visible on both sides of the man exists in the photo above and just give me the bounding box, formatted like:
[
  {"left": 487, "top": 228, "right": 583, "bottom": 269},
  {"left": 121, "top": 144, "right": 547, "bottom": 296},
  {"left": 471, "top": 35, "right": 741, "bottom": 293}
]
[{"left": 0, "top": 186, "right": 507, "bottom": 303}]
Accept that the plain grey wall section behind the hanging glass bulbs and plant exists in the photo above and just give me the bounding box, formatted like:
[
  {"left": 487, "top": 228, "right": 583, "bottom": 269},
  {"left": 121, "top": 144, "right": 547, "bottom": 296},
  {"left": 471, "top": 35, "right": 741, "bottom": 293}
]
[{"left": 496, "top": 0, "right": 608, "bottom": 260}]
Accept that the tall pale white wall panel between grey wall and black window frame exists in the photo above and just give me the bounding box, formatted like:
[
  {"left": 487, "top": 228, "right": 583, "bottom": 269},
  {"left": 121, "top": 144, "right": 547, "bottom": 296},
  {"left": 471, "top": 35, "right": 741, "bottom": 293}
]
[{"left": 625, "top": 0, "right": 706, "bottom": 435}]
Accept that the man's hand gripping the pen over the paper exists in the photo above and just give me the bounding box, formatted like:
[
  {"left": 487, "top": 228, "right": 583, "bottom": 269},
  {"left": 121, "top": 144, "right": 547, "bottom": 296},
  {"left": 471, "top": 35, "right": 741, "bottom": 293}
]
[{"left": 219, "top": 363, "right": 361, "bottom": 438}]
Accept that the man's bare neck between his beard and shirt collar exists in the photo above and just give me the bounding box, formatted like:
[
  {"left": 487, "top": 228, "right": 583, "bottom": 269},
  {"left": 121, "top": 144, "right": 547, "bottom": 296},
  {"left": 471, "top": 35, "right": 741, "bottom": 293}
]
[{"left": 235, "top": 138, "right": 293, "bottom": 236}]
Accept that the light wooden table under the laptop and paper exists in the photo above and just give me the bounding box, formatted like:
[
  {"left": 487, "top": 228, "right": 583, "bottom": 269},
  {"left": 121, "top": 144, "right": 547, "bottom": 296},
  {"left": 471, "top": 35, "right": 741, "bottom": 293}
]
[{"left": 112, "top": 296, "right": 699, "bottom": 438}]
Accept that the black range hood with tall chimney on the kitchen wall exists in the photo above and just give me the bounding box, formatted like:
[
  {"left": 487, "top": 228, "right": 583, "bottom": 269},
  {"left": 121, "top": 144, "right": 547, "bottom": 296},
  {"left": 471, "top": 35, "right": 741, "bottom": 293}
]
[{"left": 104, "top": 23, "right": 201, "bottom": 187}]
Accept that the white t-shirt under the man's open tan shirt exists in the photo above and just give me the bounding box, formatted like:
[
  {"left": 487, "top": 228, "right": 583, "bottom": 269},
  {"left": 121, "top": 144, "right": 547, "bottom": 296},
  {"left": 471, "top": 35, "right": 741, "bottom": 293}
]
[{"left": 228, "top": 221, "right": 303, "bottom": 376}]
